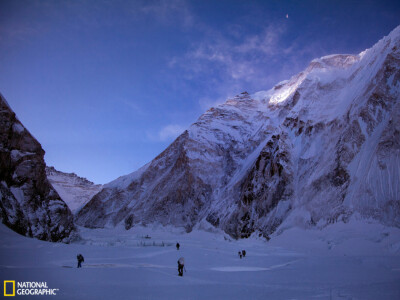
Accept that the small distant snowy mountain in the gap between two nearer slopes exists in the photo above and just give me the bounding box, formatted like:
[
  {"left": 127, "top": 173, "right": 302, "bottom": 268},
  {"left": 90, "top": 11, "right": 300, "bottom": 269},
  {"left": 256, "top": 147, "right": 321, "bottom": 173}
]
[{"left": 46, "top": 167, "right": 102, "bottom": 214}]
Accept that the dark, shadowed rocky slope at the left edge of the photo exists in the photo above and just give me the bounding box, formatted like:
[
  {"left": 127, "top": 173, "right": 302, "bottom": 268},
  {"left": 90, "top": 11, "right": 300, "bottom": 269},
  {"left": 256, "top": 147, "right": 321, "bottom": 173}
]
[{"left": 0, "top": 95, "right": 75, "bottom": 241}]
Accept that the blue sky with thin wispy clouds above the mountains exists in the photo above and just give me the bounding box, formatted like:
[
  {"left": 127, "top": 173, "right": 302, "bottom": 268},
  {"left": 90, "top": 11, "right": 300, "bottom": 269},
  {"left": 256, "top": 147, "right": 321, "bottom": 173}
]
[{"left": 0, "top": 0, "right": 400, "bottom": 183}]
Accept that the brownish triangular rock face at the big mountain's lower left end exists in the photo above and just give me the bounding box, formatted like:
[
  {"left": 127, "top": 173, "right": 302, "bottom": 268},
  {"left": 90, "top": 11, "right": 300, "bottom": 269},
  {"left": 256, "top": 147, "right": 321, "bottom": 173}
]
[{"left": 78, "top": 133, "right": 216, "bottom": 228}]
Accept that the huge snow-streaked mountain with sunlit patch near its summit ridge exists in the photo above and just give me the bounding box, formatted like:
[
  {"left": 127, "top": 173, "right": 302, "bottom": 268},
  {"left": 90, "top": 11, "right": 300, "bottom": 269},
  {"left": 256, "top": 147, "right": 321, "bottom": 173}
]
[{"left": 76, "top": 26, "right": 400, "bottom": 237}]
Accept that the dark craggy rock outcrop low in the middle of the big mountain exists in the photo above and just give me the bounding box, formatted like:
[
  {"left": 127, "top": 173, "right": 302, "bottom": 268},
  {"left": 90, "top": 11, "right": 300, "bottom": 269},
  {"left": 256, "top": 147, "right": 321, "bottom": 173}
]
[{"left": 228, "top": 132, "right": 293, "bottom": 237}]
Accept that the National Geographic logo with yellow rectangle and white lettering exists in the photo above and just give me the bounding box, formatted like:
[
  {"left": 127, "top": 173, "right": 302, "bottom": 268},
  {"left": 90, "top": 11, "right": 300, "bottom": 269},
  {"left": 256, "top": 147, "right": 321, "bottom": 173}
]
[{"left": 4, "top": 280, "right": 59, "bottom": 297}]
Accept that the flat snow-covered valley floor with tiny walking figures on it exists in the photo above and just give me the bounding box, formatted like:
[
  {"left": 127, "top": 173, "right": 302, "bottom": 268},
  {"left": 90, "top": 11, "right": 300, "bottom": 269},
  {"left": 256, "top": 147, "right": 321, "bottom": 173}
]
[{"left": 0, "top": 218, "right": 400, "bottom": 299}]
